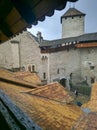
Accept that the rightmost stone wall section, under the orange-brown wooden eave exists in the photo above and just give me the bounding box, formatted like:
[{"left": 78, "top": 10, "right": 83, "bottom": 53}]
[{"left": 81, "top": 47, "right": 97, "bottom": 85}]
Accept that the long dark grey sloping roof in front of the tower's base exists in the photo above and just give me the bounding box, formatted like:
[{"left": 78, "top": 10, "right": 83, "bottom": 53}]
[{"left": 40, "top": 32, "right": 97, "bottom": 47}]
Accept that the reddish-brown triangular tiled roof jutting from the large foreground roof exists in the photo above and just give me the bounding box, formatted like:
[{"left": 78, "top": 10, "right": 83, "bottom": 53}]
[{"left": 26, "top": 82, "right": 73, "bottom": 103}]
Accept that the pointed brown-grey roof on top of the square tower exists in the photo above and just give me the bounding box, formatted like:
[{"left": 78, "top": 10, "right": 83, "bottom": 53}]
[{"left": 61, "top": 8, "right": 85, "bottom": 18}]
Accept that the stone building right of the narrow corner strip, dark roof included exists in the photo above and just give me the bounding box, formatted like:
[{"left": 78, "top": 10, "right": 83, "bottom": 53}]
[{"left": 40, "top": 33, "right": 97, "bottom": 86}]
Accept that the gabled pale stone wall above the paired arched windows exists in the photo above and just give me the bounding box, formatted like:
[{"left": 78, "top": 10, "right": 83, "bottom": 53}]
[{"left": 16, "top": 32, "right": 41, "bottom": 72}]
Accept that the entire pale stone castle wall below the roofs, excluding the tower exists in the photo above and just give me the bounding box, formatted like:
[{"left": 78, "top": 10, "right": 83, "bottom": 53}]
[{"left": 0, "top": 32, "right": 97, "bottom": 85}]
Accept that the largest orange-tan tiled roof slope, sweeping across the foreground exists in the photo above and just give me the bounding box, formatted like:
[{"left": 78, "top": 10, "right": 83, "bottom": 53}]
[{"left": 0, "top": 81, "right": 82, "bottom": 130}]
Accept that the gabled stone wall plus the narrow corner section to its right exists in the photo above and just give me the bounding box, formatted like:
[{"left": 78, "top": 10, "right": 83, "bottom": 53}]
[{"left": 14, "top": 32, "right": 48, "bottom": 80}]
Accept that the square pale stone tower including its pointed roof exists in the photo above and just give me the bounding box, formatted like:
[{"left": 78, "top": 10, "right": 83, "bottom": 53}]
[{"left": 61, "top": 8, "right": 85, "bottom": 38}]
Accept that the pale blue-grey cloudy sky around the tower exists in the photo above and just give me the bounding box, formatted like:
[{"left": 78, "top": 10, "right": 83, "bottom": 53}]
[{"left": 28, "top": 0, "right": 97, "bottom": 40}]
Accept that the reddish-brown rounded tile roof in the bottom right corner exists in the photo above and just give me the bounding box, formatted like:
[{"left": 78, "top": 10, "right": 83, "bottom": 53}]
[{"left": 73, "top": 112, "right": 97, "bottom": 130}]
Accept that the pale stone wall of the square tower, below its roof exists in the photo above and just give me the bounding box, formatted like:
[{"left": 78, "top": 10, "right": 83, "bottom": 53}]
[{"left": 62, "top": 16, "right": 84, "bottom": 38}]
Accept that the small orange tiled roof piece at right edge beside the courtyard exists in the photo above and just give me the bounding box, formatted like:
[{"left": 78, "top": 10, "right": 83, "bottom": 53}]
[{"left": 82, "top": 82, "right": 97, "bottom": 111}]
